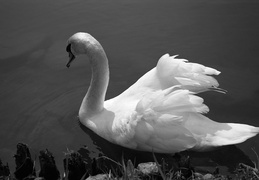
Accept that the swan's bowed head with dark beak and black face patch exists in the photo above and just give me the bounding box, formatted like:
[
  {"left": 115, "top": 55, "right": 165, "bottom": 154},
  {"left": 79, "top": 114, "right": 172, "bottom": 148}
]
[{"left": 66, "top": 32, "right": 98, "bottom": 68}]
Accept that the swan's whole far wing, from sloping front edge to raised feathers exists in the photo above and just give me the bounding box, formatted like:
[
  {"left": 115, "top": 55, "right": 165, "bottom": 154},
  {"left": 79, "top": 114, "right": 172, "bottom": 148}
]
[{"left": 120, "top": 54, "right": 226, "bottom": 100}]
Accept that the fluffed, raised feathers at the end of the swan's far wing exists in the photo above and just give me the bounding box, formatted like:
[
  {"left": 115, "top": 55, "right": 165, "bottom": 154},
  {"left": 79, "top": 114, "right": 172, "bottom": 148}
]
[{"left": 156, "top": 54, "right": 224, "bottom": 92}]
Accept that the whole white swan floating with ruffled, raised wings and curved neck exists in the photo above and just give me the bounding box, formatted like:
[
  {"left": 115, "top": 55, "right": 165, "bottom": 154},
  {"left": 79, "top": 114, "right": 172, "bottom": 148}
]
[{"left": 66, "top": 32, "right": 259, "bottom": 154}]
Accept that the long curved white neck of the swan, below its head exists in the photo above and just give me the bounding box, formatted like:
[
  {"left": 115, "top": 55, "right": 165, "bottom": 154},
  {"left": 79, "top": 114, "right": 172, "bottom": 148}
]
[{"left": 79, "top": 43, "right": 109, "bottom": 117}]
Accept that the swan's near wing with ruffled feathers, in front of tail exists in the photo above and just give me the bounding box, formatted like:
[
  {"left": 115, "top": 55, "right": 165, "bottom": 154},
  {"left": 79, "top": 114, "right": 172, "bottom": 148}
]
[{"left": 130, "top": 86, "right": 208, "bottom": 153}]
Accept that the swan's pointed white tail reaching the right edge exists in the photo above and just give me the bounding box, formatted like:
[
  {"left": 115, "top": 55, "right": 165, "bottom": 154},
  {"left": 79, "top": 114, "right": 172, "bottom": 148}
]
[{"left": 185, "top": 113, "right": 259, "bottom": 150}]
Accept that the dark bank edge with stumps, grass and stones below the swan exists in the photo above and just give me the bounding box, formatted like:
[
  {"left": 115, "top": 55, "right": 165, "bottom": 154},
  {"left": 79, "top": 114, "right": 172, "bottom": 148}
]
[{"left": 0, "top": 143, "right": 259, "bottom": 180}]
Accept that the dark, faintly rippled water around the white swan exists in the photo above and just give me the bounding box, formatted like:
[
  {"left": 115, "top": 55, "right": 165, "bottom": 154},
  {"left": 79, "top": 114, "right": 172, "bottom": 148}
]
[{"left": 0, "top": 0, "right": 259, "bottom": 174}]
